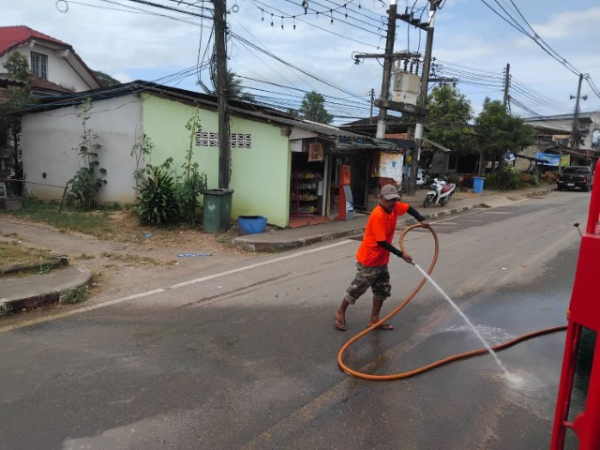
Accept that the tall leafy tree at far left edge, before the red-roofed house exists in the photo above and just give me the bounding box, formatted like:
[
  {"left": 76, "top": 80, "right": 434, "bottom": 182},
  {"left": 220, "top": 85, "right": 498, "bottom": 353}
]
[{"left": 0, "top": 52, "right": 35, "bottom": 187}]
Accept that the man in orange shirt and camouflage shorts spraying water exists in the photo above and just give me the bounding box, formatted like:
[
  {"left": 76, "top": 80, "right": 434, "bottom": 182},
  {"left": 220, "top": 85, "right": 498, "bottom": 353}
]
[{"left": 335, "top": 184, "right": 429, "bottom": 331}]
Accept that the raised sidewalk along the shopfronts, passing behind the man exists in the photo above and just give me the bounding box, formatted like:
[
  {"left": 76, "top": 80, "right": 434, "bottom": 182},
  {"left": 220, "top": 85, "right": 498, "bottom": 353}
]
[{"left": 231, "top": 186, "right": 556, "bottom": 252}]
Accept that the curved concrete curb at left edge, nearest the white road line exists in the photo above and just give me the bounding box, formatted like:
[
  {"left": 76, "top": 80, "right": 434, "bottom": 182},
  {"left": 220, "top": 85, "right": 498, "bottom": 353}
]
[{"left": 0, "top": 268, "right": 93, "bottom": 317}]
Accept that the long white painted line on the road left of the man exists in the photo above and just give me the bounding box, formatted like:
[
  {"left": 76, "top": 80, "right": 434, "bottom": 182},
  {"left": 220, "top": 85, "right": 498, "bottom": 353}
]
[{"left": 0, "top": 239, "right": 354, "bottom": 333}]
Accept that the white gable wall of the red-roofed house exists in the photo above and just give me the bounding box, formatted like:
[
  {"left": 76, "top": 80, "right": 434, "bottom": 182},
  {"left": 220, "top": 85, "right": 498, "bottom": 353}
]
[{"left": 0, "top": 44, "right": 96, "bottom": 92}]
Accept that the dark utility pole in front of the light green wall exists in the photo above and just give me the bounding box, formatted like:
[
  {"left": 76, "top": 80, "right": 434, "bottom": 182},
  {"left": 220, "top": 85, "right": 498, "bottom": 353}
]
[{"left": 212, "top": 0, "right": 231, "bottom": 189}]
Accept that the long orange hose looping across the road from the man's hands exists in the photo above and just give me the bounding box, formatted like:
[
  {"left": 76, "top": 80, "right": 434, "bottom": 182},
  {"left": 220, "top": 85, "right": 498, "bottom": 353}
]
[{"left": 338, "top": 223, "right": 567, "bottom": 381}]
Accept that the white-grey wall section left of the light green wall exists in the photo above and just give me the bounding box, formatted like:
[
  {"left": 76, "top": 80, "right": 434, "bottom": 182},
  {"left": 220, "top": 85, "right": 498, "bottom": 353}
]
[{"left": 21, "top": 95, "right": 143, "bottom": 204}]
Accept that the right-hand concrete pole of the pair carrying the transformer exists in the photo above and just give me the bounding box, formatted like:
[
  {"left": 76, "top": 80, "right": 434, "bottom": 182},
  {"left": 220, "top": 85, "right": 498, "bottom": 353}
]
[{"left": 408, "top": 0, "right": 440, "bottom": 194}]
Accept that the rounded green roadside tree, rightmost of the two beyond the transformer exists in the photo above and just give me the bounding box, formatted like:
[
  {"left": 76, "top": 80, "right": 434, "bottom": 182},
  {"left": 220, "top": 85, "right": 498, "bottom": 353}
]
[{"left": 475, "top": 98, "right": 535, "bottom": 175}]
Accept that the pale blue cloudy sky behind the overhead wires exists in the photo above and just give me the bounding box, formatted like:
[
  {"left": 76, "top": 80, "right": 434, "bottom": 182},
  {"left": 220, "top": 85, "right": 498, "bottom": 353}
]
[{"left": 0, "top": 0, "right": 600, "bottom": 124}]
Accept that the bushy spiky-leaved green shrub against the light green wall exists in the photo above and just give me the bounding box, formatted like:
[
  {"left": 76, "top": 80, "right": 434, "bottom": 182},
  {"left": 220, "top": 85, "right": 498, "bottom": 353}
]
[{"left": 136, "top": 160, "right": 180, "bottom": 226}]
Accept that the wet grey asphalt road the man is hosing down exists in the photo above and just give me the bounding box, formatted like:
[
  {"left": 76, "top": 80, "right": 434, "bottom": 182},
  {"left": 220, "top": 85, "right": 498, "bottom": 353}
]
[{"left": 0, "top": 192, "right": 589, "bottom": 450}]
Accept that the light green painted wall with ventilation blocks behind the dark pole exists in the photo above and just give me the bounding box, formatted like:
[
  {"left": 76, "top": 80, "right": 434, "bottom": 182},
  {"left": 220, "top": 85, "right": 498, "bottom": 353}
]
[{"left": 143, "top": 94, "right": 291, "bottom": 227}]
